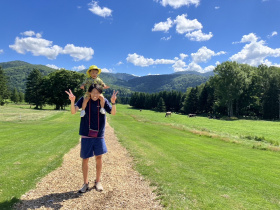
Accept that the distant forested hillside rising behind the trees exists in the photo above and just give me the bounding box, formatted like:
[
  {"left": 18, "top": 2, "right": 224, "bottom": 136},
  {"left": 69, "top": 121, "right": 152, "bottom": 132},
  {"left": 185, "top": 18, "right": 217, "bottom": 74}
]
[{"left": 0, "top": 61, "right": 210, "bottom": 93}]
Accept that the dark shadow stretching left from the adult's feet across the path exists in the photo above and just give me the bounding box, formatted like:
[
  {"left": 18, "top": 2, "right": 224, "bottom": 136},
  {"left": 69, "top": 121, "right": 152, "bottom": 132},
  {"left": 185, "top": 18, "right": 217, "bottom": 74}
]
[{"left": 0, "top": 189, "right": 86, "bottom": 210}]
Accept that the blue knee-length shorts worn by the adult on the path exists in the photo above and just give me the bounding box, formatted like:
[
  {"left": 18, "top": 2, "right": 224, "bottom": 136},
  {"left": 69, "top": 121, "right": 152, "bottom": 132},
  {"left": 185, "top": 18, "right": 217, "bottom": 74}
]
[{"left": 80, "top": 138, "right": 107, "bottom": 159}]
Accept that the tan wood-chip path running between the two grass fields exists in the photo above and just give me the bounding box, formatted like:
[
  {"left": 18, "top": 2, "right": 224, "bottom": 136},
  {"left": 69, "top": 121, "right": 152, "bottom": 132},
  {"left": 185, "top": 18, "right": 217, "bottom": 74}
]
[{"left": 15, "top": 124, "right": 162, "bottom": 210}]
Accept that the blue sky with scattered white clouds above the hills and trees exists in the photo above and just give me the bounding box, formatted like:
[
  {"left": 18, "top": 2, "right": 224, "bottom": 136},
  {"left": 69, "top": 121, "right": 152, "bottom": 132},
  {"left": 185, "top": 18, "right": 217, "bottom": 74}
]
[{"left": 0, "top": 0, "right": 280, "bottom": 76}]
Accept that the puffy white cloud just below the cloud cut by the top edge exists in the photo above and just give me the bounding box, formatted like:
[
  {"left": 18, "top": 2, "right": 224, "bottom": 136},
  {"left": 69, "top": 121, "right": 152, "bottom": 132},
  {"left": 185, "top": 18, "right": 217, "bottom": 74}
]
[{"left": 152, "top": 14, "right": 213, "bottom": 42}]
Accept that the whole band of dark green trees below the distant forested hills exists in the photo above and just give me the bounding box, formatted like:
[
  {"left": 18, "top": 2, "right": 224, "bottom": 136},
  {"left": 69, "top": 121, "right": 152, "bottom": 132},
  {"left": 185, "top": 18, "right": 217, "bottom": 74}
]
[{"left": 0, "top": 61, "right": 280, "bottom": 120}]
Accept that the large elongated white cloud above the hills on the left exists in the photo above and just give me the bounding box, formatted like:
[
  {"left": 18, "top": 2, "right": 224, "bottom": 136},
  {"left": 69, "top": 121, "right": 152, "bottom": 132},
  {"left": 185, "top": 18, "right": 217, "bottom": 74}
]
[{"left": 9, "top": 31, "right": 94, "bottom": 61}]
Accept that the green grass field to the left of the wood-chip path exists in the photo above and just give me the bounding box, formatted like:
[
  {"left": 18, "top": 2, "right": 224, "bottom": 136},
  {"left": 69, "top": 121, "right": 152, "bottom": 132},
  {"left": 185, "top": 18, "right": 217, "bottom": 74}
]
[{"left": 0, "top": 105, "right": 79, "bottom": 209}]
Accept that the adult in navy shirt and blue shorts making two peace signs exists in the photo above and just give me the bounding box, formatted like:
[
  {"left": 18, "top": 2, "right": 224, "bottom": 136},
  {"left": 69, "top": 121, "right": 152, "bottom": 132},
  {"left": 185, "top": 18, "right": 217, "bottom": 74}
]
[{"left": 65, "top": 85, "right": 118, "bottom": 193}]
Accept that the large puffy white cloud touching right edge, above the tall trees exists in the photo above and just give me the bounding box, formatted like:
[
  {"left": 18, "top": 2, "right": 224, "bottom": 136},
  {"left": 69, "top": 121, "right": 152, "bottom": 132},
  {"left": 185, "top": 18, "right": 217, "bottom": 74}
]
[{"left": 230, "top": 33, "right": 280, "bottom": 66}]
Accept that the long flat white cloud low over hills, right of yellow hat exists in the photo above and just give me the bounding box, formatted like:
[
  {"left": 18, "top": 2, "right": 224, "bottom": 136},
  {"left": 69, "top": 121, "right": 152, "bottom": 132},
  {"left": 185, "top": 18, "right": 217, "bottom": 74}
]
[{"left": 126, "top": 53, "right": 175, "bottom": 67}]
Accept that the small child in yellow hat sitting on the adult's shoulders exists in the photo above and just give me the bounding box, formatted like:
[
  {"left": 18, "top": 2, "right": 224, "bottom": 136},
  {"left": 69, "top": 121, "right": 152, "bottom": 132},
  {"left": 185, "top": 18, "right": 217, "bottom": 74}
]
[{"left": 80, "top": 65, "right": 110, "bottom": 117}]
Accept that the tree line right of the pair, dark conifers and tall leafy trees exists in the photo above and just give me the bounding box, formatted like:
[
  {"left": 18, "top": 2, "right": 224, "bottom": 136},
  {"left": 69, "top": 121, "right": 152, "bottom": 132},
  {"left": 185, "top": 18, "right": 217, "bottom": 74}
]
[{"left": 130, "top": 61, "right": 280, "bottom": 119}]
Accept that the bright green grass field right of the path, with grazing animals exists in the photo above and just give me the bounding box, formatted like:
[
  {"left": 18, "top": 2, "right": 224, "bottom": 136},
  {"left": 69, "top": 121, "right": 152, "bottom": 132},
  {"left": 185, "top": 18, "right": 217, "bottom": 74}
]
[{"left": 109, "top": 105, "right": 280, "bottom": 209}]
